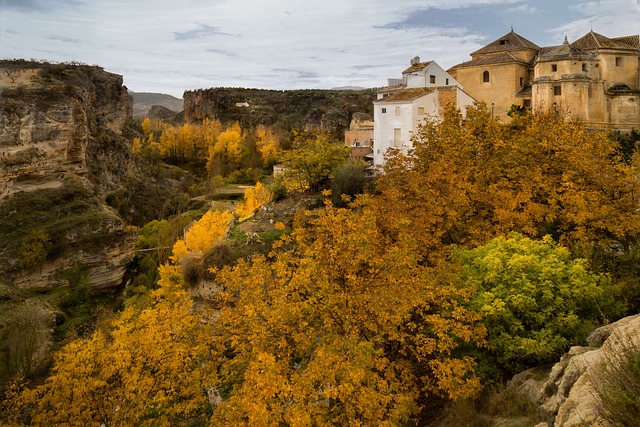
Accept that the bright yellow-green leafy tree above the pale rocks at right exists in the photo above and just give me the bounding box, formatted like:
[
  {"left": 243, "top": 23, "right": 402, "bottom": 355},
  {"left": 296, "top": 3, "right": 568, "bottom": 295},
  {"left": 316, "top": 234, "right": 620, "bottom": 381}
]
[{"left": 453, "top": 234, "right": 610, "bottom": 374}]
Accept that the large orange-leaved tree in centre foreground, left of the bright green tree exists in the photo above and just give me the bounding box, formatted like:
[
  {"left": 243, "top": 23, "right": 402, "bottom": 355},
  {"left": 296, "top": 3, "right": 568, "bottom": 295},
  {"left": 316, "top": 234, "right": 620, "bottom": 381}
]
[{"left": 213, "top": 201, "right": 484, "bottom": 426}]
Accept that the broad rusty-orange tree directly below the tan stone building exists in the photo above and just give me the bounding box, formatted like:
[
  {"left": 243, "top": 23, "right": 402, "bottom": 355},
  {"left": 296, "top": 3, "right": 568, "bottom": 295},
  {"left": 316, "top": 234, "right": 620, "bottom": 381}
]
[{"left": 376, "top": 105, "right": 640, "bottom": 264}]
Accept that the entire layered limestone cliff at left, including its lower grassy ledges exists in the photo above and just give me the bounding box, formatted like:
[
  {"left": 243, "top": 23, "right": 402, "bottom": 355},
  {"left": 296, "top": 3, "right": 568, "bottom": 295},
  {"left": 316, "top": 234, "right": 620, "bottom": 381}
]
[{"left": 0, "top": 61, "right": 135, "bottom": 289}]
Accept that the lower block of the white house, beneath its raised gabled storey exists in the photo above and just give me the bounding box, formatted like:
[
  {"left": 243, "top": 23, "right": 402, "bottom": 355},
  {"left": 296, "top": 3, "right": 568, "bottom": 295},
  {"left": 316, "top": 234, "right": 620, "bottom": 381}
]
[{"left": 373, "top": 85, "right": 474, "bottom": 167}]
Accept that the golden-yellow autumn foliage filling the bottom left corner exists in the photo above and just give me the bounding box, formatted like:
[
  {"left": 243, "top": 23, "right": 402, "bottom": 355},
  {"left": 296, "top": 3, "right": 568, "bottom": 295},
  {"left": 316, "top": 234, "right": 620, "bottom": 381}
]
[{"left": 0, "top": 266, "right": 212, "bottom": 426}]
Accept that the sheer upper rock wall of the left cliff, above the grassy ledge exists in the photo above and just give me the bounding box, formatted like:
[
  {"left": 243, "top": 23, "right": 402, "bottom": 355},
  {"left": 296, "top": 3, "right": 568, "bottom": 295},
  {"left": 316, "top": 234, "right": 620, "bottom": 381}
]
[{"left": 0, "top": 63, "right": 133, "bottom": 201}]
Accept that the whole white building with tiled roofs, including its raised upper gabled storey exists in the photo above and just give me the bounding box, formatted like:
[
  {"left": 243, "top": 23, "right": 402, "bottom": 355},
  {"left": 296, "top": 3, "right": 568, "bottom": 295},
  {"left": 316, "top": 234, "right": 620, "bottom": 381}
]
[{"left": 373, "top": 57, "right": 475, "bottom": 167}]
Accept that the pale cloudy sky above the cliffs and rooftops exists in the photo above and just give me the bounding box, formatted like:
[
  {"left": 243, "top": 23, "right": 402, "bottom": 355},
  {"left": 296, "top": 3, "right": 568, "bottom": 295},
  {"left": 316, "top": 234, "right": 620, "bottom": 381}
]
[{"left": 0, "top": 0, "right": 640, "bottom": 97}]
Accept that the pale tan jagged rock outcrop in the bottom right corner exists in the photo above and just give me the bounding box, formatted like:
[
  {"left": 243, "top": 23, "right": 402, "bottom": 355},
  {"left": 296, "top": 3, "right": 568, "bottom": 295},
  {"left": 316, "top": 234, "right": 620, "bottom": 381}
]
[{"left": 509, "top": 314, "right": 640, "bottom": 427}]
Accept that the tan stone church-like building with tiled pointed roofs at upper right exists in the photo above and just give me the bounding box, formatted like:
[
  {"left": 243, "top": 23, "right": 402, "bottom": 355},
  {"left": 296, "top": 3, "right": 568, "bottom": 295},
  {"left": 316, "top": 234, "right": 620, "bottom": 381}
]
[{"left": 448, "top": 30, "right": 640, "bottom": 130}]
